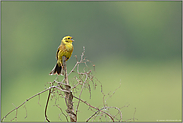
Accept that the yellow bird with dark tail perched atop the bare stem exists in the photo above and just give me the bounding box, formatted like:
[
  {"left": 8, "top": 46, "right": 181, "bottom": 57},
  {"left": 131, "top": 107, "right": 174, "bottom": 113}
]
[{"left": 49, "top": 36, "right": 74, "bottom": 75}]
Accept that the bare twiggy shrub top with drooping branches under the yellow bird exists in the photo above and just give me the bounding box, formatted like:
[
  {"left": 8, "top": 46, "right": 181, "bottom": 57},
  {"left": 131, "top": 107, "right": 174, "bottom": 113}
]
[{"left": 1, "top": 47, "right": 136, "bottom": 122}]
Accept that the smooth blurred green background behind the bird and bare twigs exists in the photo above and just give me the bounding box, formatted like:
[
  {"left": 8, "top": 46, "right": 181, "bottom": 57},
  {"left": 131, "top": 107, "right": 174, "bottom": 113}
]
[{"left": 1, "top": 1, "right": 182, "bottom": 122}]
